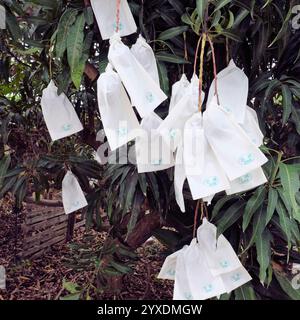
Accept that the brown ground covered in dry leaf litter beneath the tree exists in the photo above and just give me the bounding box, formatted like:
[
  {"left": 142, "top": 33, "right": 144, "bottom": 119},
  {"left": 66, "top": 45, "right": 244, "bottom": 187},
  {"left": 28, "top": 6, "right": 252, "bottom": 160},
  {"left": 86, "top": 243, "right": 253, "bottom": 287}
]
[{"left": 0, "top": 202, "right": 173, "bottom": 300}]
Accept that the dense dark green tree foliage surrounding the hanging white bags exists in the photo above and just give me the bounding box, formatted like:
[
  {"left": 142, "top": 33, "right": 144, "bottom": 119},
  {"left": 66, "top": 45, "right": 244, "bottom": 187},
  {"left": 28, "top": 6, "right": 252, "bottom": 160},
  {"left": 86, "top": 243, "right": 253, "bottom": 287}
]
[{"left": 0, "top": 0, "right": 300, "bottom": 299}]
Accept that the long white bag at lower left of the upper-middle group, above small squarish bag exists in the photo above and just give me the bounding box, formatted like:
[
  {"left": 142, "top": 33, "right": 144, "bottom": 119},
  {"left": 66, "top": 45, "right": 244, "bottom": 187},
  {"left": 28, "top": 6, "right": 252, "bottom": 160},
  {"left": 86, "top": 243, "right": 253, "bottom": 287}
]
[{"left": 97, "top": 64, "right": 139, "bottom": 151}]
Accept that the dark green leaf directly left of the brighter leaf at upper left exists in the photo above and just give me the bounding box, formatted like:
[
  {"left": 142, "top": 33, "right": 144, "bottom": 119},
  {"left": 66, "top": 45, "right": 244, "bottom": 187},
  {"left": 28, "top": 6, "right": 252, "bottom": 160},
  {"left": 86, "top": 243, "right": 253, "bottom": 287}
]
[{"left": 55, "top": 9, "right": 78, "bottom": 58}]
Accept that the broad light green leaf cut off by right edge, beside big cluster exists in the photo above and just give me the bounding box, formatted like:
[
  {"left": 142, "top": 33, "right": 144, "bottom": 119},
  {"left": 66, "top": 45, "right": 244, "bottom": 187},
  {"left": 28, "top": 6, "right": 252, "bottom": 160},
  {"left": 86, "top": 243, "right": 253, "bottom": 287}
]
[{"left": 279, "top": 163, "right": 300, "bottom": 222}]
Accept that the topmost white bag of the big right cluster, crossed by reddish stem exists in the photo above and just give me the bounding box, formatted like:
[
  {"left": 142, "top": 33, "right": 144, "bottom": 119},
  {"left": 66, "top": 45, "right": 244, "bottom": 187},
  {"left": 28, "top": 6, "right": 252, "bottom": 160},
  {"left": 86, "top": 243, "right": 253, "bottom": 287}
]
[{"left": 207, "top": 60, "right": 249, "bottom": 123}]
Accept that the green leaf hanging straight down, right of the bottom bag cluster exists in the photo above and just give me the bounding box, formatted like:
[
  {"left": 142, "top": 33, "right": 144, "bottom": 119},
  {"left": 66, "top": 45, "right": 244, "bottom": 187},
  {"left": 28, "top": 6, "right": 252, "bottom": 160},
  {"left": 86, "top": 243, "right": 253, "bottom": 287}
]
[{"left": 255, "top": 229, "right": 272, "bottom": 283}]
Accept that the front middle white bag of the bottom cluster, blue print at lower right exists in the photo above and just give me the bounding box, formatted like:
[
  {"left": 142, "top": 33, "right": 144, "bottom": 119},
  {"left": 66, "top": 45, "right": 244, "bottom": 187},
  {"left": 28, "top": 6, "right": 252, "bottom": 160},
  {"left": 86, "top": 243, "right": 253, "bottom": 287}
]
[{"left": 184, "top": 239, "right": 226, "bottom": 300}]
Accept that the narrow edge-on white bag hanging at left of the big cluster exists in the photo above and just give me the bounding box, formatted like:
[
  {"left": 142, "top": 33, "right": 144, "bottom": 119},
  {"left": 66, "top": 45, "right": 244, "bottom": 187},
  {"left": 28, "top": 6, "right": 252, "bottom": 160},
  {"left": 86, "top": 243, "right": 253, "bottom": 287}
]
[{"left": 174, "top": 143, "right": 186, "bottom": 212}]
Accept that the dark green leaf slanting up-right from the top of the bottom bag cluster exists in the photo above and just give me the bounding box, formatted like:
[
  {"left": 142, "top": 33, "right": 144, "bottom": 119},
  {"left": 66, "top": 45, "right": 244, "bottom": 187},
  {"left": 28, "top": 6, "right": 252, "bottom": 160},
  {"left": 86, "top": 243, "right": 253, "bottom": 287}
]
[{"left": 216, "top": 201, "right": 245, "bottom": 237}]
